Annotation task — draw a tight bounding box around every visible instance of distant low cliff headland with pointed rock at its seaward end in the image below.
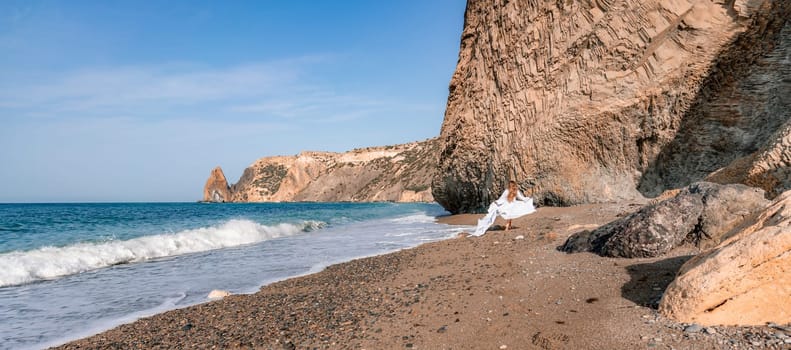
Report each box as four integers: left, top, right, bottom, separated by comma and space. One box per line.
203, 139, 437, 202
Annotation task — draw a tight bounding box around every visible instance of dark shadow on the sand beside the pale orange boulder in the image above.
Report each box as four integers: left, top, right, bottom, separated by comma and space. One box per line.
621, 255, 694, 309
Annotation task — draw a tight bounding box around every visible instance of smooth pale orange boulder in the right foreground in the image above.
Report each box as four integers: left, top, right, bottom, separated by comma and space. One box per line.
659, 191, 791, 325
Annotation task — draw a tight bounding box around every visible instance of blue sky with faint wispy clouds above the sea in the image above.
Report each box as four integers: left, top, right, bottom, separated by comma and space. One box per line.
0, 0, 466, 202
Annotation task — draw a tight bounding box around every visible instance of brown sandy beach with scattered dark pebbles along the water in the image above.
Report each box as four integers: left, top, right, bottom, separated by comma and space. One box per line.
59, 203, 791, 349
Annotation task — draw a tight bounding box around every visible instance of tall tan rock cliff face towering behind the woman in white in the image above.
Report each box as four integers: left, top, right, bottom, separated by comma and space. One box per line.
432, 0, 791, 213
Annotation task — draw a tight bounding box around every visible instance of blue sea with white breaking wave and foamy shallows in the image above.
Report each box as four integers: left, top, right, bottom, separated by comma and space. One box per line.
0, 203, 469, 349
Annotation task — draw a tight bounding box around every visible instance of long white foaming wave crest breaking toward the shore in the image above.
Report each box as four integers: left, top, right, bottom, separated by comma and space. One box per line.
0, 219, 326, 287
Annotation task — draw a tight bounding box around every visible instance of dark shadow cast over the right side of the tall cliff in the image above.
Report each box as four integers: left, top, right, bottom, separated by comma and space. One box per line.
637, 1, 791, 197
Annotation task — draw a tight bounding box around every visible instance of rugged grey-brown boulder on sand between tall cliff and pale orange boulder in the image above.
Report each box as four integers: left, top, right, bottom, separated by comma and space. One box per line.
561, 182, 768, 258
